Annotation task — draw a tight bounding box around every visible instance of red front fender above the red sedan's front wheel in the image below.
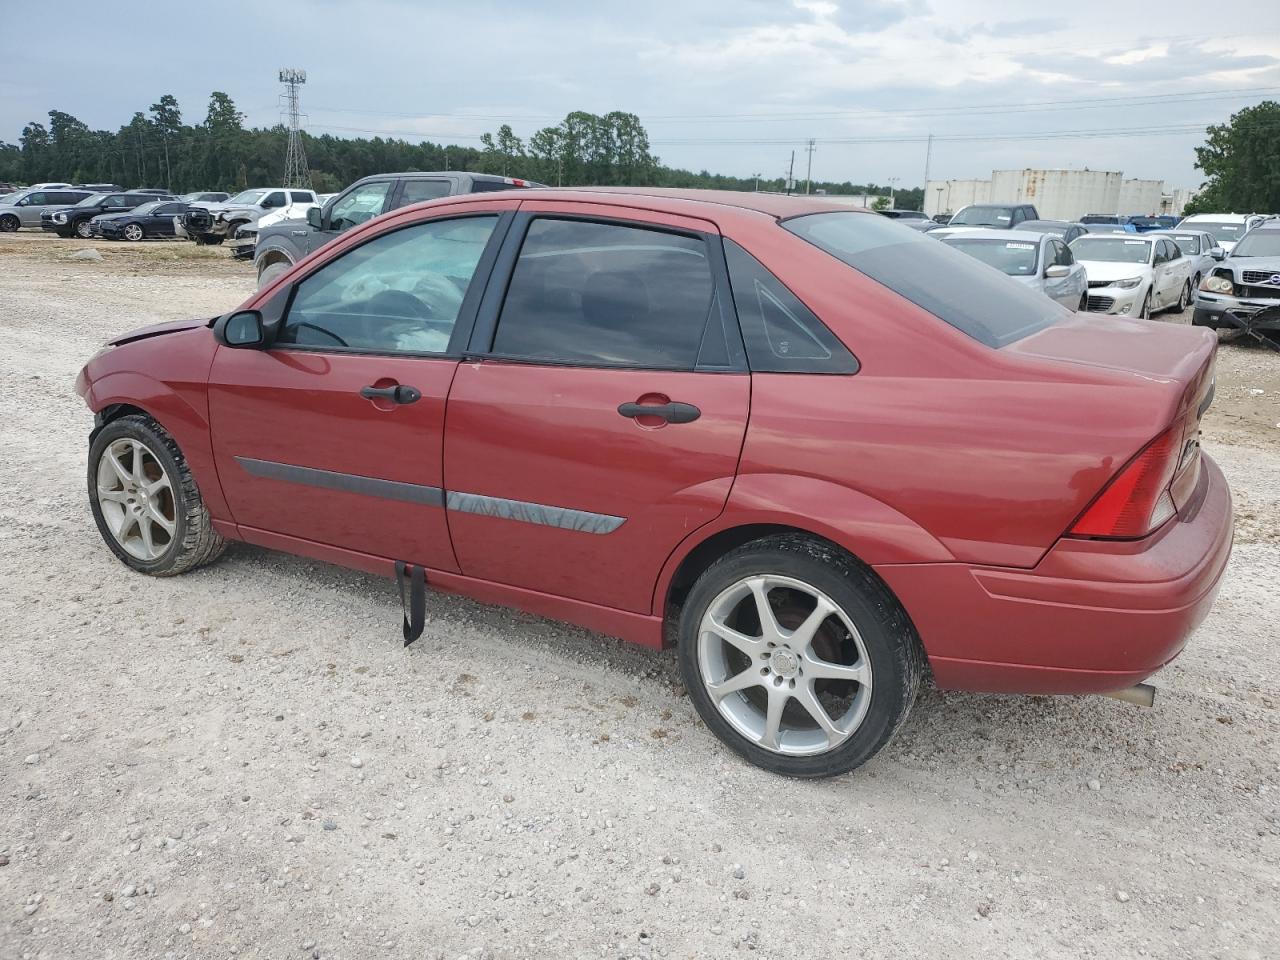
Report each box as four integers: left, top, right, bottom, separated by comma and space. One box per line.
76, 362, 230, 521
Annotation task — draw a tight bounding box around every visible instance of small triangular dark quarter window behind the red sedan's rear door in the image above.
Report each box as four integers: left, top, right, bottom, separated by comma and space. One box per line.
724, 239, 858, 374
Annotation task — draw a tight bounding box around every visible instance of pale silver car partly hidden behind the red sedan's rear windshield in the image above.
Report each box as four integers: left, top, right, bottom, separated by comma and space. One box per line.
933, 229, 1088, 310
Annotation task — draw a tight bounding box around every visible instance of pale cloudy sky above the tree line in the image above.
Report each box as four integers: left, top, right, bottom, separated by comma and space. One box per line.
0, 0, 1280, 187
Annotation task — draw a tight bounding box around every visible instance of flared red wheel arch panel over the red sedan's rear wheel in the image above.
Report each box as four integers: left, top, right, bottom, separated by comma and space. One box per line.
653, 474, 955, 616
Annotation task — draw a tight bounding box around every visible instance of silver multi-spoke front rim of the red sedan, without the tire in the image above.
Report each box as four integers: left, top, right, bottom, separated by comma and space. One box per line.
97, 438, 178, 561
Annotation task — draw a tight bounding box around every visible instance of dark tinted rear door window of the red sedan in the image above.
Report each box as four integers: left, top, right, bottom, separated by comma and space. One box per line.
493, 218, 713, 370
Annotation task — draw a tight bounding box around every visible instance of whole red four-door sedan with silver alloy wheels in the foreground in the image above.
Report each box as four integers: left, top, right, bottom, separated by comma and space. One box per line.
77, 189, 1231, 777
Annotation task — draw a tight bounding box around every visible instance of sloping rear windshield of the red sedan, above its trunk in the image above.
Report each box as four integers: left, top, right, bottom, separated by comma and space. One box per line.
782, 212, 1071, 347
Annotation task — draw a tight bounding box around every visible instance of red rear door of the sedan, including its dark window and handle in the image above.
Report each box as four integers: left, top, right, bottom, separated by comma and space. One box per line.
444, 201, 750, 613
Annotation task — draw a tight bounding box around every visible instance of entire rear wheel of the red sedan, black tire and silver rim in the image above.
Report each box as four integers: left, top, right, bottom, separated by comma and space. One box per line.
678, 534, 924, 778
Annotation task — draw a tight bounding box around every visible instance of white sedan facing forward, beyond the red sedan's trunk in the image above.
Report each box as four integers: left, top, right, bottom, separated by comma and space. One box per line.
1071, 233, 1192, 319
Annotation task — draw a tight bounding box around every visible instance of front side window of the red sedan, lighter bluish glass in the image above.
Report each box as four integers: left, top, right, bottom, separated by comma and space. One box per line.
278, 216, 498, 353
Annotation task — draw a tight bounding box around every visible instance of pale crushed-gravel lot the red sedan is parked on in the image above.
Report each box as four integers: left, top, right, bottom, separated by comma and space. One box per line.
0, 233, 1280, 960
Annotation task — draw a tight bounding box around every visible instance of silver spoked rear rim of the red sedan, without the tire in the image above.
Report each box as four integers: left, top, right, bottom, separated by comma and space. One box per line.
698, 575, 872, 756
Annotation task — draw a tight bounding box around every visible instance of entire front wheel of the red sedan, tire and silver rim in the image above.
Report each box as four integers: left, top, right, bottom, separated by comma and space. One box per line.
88, 415, 227, 576
